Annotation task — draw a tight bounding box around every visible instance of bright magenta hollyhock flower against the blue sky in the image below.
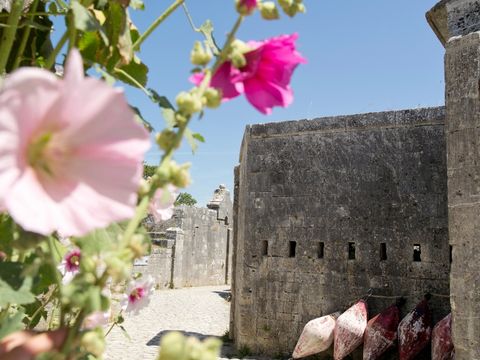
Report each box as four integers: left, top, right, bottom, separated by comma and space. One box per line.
191, 34, 306, 114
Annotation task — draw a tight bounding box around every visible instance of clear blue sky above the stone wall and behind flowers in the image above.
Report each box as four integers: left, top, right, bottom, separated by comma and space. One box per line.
79, 0, 444, 206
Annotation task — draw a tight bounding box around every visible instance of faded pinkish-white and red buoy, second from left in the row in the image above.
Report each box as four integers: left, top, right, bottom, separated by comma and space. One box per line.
334, 300, 368, 360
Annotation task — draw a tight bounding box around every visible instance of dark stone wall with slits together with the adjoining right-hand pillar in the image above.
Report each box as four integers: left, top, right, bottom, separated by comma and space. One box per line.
231, 0, 480, 360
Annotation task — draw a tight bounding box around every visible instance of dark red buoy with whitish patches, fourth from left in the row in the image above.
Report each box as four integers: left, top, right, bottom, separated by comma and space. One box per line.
398, 300, 432, 360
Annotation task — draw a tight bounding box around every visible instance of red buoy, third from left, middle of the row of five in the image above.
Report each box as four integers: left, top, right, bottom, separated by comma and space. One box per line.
363, 305, 400, 360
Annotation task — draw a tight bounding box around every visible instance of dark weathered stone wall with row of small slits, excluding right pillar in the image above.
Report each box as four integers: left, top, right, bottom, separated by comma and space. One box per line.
231, 107, 450, 354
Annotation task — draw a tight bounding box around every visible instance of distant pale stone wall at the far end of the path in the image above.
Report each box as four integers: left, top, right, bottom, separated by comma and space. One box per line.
134, 185, 232, 288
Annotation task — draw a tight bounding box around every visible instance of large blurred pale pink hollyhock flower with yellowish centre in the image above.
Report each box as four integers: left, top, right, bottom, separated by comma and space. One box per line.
0, 50, 149, 236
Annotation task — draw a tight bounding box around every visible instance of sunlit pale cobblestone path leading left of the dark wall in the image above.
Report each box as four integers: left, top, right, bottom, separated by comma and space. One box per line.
105, 286, 231, 360
